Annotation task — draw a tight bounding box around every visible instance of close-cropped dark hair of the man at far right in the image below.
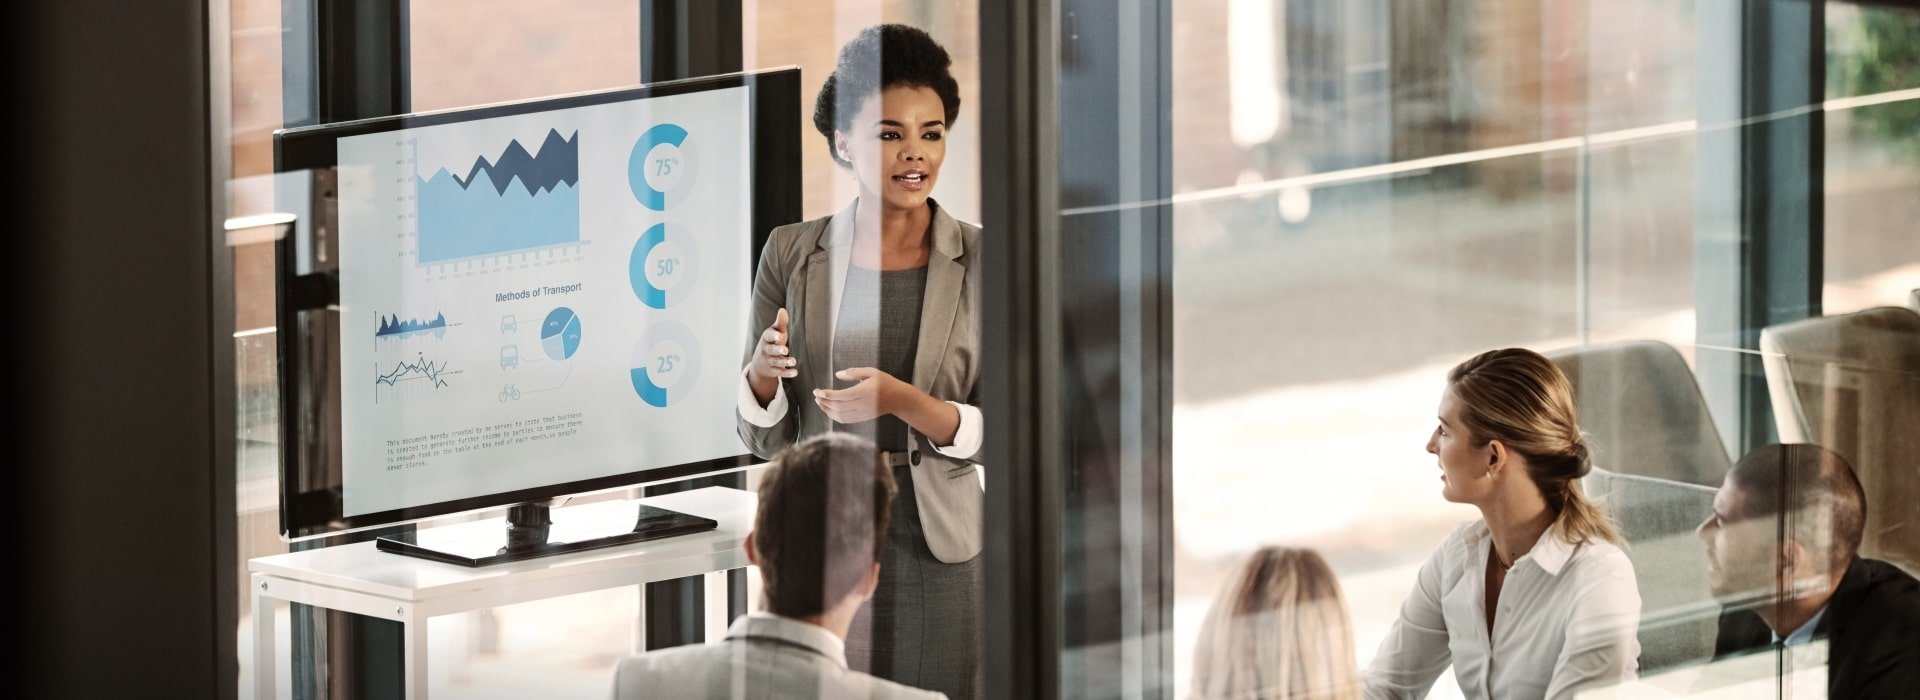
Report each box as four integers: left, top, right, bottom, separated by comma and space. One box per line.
1726, 443, 1866, 572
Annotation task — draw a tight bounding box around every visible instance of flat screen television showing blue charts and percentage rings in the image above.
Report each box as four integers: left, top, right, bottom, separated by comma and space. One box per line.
275, 69, 801, 564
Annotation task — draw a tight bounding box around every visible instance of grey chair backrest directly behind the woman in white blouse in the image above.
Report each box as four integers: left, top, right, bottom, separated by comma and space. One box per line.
1546, 339, 1734, 487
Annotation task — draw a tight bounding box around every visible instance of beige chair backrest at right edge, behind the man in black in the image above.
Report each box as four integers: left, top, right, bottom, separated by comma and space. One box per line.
1761, 307, 1920, 572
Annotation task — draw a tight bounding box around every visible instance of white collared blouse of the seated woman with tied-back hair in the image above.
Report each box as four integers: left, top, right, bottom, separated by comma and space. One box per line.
1367, 520, 1640, 700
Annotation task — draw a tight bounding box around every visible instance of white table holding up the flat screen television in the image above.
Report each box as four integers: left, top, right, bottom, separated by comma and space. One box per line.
248, 487, 756, 698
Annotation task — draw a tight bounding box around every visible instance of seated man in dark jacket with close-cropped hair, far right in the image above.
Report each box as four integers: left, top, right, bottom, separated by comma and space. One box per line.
1699, 445, 1920, 698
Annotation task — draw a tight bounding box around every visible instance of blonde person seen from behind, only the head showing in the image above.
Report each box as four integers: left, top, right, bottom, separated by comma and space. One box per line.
1190, 547, 1359, 700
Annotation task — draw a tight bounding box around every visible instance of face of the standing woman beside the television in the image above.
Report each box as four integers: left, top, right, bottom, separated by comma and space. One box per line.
833, 86, 947, 211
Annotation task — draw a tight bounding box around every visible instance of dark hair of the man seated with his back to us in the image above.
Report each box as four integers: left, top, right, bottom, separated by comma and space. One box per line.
753, 433, 899, 618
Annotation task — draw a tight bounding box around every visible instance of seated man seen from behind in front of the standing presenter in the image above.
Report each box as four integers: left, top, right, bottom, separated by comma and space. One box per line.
614, 433, 945, 700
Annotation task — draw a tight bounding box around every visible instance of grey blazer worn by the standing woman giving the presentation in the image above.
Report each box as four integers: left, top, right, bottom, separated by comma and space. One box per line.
737, 201, 981, 564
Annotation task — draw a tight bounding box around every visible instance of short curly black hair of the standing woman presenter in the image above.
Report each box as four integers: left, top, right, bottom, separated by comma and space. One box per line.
814, 25, 960, 165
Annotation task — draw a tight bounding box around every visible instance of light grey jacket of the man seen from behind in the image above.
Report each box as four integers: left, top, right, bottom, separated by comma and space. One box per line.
612, 612, 947, 700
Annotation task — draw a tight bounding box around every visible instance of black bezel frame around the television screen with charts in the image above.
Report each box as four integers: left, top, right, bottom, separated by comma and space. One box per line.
273, 67, 803, 539
